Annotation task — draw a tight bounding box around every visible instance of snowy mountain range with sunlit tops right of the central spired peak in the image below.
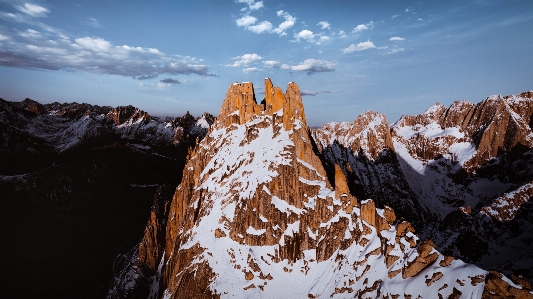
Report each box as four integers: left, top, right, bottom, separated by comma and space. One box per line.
313, 92, 533, 286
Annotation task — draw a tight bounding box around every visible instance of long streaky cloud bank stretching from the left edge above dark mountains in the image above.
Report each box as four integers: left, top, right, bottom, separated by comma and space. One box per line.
0, 29, 211, 79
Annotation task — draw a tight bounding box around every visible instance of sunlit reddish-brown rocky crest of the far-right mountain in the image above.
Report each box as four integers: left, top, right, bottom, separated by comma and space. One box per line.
392, 91, 533, 171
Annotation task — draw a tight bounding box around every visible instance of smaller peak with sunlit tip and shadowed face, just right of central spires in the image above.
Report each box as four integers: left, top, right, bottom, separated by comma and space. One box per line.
312, 111, 429, 229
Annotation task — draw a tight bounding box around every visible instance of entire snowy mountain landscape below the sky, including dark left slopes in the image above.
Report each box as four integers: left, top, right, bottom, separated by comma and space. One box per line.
0, 79, 533, 298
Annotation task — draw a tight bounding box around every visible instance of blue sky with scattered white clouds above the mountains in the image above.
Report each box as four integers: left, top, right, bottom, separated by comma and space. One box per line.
0, 0, 533, 126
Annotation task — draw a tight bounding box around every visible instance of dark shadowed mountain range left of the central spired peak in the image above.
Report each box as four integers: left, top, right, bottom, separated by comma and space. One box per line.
0, 99, 213, 298
